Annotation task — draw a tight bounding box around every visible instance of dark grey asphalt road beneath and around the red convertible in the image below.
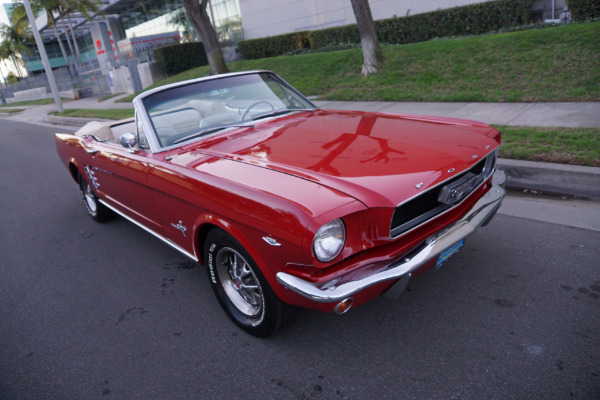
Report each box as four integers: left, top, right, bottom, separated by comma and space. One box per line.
0, 119, 600, 400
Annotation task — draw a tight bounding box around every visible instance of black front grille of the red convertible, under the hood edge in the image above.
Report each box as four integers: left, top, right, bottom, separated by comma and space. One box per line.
390, 152, 496, 238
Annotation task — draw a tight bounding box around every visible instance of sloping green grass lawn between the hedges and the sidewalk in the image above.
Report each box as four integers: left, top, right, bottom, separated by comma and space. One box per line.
118, 22, 600, 102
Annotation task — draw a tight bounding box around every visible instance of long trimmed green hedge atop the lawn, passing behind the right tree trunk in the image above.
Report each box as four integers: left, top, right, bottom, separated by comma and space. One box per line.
238, 0, 536, 59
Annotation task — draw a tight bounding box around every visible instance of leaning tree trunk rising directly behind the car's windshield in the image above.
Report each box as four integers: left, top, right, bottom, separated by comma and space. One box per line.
183, 0, 229, 74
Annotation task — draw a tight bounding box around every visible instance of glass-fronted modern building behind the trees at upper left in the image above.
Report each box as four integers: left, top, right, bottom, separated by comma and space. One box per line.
24, 0, 243, 74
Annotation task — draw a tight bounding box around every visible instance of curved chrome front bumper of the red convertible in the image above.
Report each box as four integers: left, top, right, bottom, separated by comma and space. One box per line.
277, 170, 506, 303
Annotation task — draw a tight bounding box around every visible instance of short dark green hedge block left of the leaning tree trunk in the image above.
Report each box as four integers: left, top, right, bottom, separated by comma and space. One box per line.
152, 42, 208, 76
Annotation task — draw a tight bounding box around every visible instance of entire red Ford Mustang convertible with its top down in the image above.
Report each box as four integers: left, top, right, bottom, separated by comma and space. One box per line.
56, 71, 505, 337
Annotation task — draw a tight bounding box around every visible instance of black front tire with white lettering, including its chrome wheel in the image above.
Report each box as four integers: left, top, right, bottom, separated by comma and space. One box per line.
204, 228, 294, 337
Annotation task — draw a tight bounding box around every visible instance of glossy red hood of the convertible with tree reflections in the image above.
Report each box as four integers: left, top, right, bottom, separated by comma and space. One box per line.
182, 110, 498, 207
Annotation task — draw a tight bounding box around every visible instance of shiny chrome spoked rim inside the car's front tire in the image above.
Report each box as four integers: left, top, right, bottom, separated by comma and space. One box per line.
215, 247, 264, 318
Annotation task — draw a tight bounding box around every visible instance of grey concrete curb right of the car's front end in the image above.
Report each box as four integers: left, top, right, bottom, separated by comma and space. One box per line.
496, 159, 600, 200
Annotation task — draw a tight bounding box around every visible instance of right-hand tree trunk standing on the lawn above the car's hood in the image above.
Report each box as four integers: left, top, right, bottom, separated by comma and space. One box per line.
350, 0, 383, 76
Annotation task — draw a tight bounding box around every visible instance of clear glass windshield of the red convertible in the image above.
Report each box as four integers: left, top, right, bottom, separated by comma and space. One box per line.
142, 73, 316, 148
